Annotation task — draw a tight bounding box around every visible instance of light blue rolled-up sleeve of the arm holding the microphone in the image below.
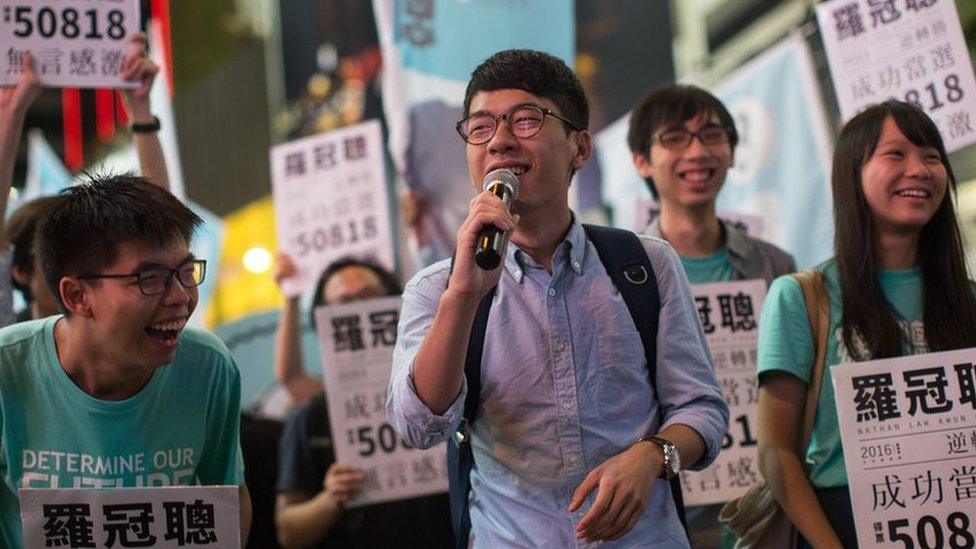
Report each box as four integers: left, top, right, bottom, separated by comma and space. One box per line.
386, 260, 467, 448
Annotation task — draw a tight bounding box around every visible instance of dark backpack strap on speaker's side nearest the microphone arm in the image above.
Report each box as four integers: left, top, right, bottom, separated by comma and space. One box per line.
447, 282, 495, 549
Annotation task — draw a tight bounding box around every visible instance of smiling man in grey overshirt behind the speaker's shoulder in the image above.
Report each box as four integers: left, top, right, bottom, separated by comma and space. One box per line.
627, 85, 796, 547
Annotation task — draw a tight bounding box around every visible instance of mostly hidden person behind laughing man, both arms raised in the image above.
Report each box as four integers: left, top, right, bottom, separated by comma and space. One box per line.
0, 33, 169, 326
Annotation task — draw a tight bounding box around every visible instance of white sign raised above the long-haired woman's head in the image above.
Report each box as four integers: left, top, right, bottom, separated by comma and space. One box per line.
817, 0, 976, 152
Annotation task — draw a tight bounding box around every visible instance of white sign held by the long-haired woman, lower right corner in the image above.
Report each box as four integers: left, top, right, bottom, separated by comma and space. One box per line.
830, 349, 976, 548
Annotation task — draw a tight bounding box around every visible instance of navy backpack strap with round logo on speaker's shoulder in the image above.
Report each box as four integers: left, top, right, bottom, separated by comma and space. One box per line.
583, 224, 688, 534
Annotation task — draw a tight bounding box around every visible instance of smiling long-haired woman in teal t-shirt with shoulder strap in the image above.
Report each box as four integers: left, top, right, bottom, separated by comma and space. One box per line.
758, 100, 976, 547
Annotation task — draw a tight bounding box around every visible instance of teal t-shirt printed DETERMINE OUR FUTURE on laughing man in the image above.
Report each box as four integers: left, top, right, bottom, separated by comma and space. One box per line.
0, 316, 244, 547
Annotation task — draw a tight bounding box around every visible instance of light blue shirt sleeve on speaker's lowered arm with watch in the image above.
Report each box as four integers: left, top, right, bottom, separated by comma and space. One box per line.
641, 236, 729, 470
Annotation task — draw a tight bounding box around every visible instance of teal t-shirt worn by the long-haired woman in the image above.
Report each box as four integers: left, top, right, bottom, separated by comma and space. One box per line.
758, 260, 927, 488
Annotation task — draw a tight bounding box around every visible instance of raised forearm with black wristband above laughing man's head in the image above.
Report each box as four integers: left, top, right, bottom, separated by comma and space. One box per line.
122, 33, 170, 190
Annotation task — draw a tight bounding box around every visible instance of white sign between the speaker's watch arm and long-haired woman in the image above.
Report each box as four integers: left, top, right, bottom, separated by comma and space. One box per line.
681, 280, 766, 506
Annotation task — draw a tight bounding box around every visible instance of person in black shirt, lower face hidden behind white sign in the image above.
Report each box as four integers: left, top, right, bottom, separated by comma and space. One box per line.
275, 254, 452, 547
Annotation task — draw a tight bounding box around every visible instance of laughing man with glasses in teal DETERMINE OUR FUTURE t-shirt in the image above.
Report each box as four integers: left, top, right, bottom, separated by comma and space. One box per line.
0, 175, 250, 547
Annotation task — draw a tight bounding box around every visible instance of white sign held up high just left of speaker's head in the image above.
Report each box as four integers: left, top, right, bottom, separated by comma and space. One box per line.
271, 120, 393, 296
